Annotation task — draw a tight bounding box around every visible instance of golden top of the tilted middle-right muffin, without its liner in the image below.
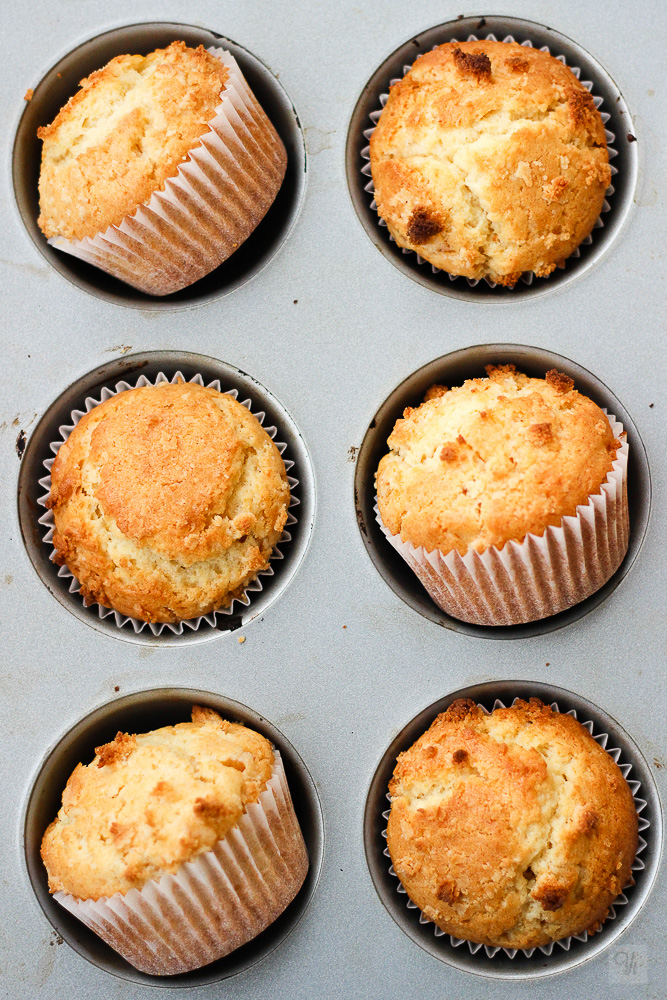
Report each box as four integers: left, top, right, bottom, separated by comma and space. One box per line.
376, 365, 619, 554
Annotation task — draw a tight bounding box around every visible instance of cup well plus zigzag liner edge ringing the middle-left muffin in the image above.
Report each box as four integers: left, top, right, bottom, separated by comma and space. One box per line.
18, 352, 314, 645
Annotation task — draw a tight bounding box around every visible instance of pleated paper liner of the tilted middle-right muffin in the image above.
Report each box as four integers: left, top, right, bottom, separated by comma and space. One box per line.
375, 409, 630, 625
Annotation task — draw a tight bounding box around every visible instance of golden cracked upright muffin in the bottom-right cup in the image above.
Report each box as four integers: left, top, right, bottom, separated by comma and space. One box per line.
387, 698, 638, 948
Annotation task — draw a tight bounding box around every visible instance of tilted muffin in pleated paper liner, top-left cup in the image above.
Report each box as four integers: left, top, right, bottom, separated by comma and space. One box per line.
37, 41, 287, 294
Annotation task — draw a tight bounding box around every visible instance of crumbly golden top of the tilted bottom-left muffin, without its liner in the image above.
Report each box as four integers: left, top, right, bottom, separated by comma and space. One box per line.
42, 706, 274, 900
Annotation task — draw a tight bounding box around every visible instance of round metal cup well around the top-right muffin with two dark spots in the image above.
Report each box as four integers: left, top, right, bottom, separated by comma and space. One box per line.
346, 16, 638, 302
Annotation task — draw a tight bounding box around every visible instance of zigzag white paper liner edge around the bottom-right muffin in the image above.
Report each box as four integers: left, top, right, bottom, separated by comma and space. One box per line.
381, 698, 651, 958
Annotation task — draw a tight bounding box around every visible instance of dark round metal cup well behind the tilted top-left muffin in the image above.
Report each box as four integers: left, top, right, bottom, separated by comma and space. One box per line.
12, 22, 306, 309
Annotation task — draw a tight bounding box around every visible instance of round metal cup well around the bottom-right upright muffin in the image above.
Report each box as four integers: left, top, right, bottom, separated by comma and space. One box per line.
364, 681, 662, 979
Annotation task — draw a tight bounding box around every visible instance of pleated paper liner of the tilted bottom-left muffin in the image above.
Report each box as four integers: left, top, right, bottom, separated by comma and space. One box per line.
54, 751, 308, 976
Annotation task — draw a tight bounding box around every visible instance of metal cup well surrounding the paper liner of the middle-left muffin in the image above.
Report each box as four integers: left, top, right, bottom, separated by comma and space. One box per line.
18, 351, 315, 646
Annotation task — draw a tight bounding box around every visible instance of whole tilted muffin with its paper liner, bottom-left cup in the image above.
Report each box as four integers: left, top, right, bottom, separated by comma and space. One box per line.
42, 706, 308, 975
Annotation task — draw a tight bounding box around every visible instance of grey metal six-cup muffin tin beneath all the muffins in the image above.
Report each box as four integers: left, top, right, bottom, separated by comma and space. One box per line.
6, 7, 667, 1000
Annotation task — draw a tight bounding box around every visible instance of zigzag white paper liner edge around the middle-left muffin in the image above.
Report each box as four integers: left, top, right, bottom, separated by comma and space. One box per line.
37, 371, 301, 635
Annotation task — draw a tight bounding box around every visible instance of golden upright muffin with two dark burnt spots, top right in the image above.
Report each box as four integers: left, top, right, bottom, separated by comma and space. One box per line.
370, 41, 611, 286
